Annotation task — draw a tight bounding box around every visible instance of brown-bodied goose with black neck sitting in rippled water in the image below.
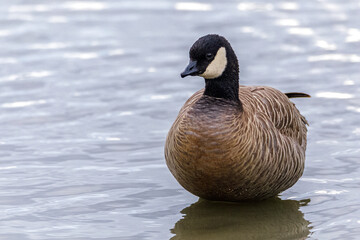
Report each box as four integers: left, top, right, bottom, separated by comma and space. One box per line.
165, 34, 310, 202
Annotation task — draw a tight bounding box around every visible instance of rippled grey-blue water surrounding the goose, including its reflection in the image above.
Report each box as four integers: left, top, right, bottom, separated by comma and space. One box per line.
0, 0, 360, 240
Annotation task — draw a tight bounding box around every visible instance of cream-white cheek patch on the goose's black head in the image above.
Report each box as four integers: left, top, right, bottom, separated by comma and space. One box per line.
199, 47, 227, 79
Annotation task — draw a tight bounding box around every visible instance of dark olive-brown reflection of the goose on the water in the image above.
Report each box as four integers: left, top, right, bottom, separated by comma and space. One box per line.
171, 198, 310, 240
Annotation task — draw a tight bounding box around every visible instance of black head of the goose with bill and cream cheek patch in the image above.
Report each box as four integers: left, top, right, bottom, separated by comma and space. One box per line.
181, 34, 239, 79
